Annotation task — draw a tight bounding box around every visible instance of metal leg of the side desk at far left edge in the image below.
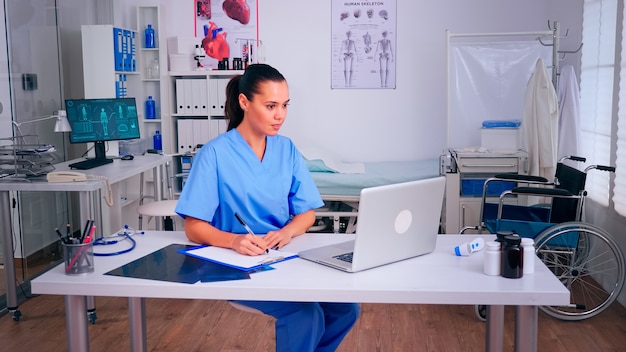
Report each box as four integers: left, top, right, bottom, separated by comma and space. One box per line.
0, 191, 21, 321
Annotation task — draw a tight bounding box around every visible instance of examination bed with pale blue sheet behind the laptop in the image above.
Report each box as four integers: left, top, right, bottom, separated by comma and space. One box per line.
307, 157, 439, 233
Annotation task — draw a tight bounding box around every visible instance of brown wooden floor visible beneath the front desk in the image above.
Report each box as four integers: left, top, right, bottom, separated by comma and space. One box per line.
0, 296, 626, 352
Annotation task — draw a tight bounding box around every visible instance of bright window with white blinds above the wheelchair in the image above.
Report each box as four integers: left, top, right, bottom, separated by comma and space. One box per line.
580, 0, 626, 209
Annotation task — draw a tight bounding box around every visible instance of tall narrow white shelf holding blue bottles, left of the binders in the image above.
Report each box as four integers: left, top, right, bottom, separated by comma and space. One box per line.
137, 5, 167, 152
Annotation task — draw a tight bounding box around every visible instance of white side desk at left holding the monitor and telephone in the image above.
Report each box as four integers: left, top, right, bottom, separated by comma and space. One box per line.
0, 154, 171, 320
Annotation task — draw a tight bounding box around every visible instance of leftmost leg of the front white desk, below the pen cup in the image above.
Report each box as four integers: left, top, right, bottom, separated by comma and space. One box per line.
65, 296, 89, 352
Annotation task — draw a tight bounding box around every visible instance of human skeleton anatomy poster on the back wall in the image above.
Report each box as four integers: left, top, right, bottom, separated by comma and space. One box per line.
331, 0, 397, 89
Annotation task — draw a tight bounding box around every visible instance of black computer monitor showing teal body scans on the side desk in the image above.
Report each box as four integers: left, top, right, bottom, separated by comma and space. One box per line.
65, 98, 140, 167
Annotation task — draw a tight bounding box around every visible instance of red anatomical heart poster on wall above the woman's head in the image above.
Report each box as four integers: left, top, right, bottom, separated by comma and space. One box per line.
194, 0, 258, 69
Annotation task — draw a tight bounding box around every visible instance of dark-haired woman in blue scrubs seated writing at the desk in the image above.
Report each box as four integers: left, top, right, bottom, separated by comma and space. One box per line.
176, 64, 360, 352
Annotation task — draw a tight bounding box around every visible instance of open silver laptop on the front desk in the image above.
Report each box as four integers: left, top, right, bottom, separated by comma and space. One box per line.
298, 177, 446, 272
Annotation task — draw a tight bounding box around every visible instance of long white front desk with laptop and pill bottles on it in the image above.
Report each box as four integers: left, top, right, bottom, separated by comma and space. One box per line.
31, 231, 570, 351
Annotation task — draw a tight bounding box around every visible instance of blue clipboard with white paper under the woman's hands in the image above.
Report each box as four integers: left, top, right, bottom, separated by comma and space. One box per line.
179, 245, 298, 272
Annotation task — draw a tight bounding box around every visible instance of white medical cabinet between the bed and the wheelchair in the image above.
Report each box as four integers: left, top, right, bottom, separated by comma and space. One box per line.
441, 150, 528, 233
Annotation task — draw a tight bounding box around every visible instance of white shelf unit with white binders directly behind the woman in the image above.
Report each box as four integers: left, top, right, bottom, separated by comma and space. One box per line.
163, 70, 243, 193
